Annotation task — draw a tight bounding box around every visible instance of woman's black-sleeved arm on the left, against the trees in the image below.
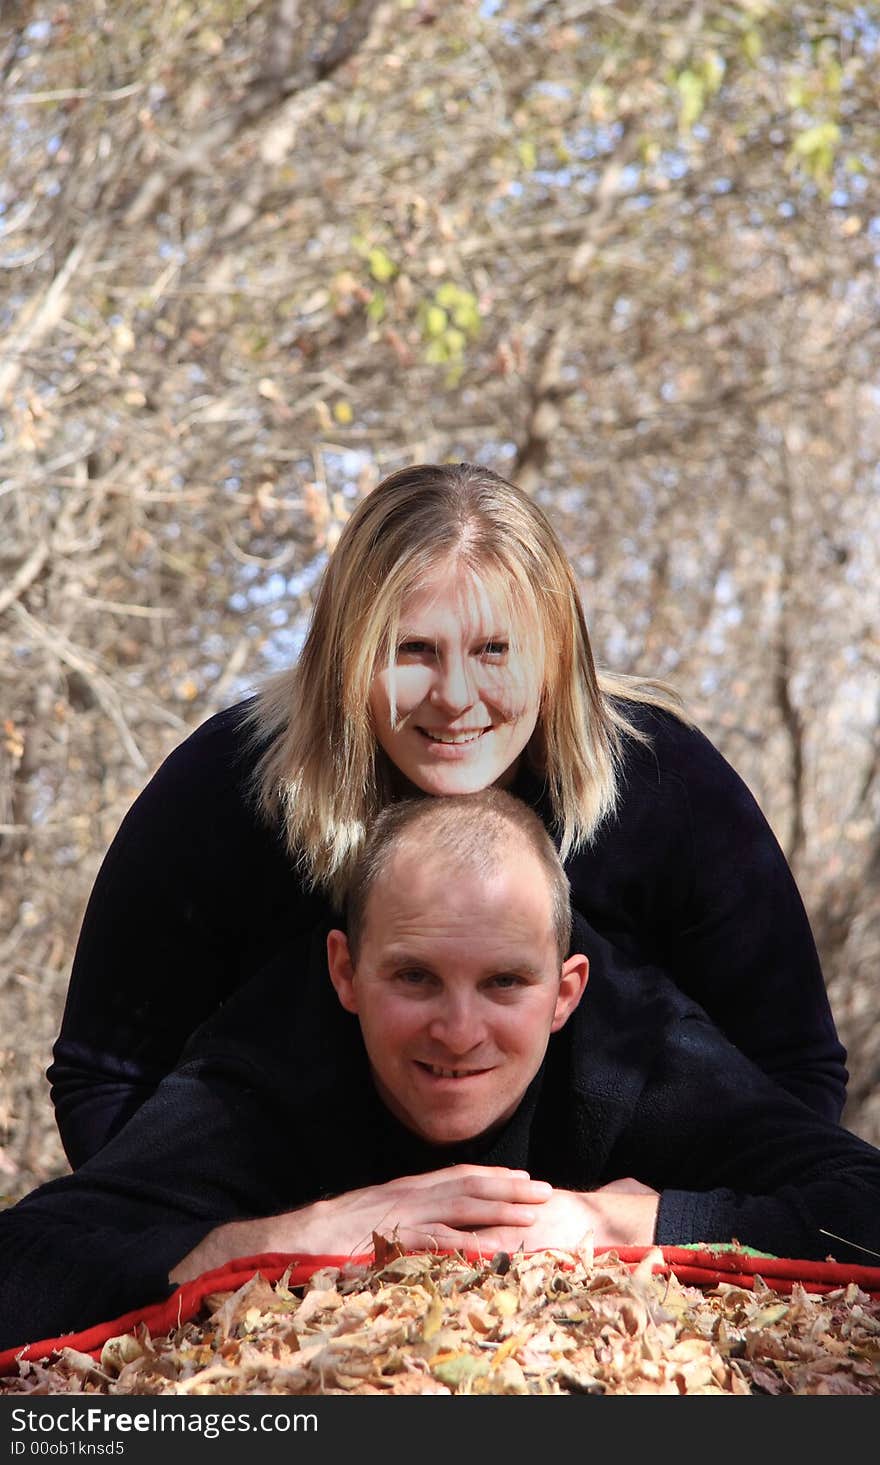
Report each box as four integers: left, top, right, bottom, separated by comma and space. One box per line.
48, 708, 319, 1166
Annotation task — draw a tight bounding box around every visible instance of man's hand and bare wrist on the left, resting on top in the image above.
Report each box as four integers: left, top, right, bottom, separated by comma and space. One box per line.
170, 1165, 550, 1283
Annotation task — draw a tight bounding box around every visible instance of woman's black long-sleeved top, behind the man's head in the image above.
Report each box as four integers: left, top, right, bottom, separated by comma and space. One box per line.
48, 703, 846, 1166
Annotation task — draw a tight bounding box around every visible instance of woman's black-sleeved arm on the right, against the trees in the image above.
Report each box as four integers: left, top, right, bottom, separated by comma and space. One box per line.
568, 708, 848, 1121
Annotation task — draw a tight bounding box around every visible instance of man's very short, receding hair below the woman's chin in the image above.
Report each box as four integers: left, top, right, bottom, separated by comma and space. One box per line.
346, 788, 571, 963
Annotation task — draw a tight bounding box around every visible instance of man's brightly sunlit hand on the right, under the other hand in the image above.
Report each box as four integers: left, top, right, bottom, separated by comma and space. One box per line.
495, 1179, 660, 1251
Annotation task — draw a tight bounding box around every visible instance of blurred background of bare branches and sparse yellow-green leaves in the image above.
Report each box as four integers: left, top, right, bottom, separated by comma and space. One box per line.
0, 0, 880, 1198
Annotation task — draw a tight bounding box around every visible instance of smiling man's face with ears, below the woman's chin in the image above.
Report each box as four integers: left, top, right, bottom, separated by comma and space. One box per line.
328, 826, 587, 1144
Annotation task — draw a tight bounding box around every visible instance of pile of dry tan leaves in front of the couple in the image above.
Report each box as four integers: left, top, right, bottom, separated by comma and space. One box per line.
0, 1247, 880, 1395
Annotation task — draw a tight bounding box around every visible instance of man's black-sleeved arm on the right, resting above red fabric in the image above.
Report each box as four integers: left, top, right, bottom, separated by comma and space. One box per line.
606, 1014, 880, 1264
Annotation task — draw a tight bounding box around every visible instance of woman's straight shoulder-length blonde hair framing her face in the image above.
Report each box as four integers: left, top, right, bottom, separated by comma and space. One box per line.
250, 463, 682, 904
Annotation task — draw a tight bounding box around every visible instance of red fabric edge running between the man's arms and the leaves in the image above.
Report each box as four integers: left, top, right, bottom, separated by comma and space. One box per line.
0, 1247, 880, 1374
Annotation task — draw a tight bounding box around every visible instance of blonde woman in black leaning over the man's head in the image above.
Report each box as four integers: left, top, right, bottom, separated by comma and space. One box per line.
48, 463, 846, 1166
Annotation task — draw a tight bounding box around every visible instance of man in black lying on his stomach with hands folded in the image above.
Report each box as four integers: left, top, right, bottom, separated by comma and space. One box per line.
0, 790, 880, 1346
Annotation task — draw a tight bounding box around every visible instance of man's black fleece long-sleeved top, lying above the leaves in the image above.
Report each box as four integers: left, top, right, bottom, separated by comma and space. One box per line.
0, 921, 880, 1348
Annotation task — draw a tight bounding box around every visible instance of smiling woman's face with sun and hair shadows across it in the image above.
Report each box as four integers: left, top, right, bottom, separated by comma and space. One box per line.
370, 561, 543, 795
